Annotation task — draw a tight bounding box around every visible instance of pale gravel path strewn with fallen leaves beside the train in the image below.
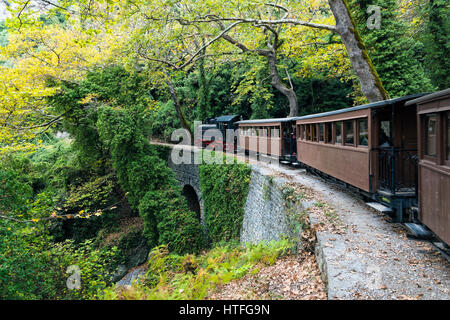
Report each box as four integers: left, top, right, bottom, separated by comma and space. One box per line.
268, 167, 450, 300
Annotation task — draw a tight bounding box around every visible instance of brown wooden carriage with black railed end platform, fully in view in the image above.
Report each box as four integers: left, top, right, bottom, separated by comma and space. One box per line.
296, 94, 423, 222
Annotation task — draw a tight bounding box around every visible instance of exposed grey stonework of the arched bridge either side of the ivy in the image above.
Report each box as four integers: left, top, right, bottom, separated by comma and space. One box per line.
163, 145, 291, 243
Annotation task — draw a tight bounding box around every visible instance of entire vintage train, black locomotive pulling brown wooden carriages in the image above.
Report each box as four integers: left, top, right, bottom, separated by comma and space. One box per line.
195, 89, 450, 249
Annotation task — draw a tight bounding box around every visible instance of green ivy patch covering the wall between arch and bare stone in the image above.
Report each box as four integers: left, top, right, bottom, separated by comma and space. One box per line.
199, 161, 251, 243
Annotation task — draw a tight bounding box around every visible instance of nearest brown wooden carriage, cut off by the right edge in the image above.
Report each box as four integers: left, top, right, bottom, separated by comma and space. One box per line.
406, 89, 450, 243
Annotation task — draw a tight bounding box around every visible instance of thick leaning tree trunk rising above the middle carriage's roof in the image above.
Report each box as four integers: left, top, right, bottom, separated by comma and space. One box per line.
328, 0, 389, 102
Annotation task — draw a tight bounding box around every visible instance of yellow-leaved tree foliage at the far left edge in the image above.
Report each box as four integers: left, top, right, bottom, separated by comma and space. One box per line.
0, 3, 118, 150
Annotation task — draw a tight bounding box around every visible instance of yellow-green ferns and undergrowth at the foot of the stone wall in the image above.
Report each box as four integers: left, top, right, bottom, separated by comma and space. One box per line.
100, 240, 292, 300
